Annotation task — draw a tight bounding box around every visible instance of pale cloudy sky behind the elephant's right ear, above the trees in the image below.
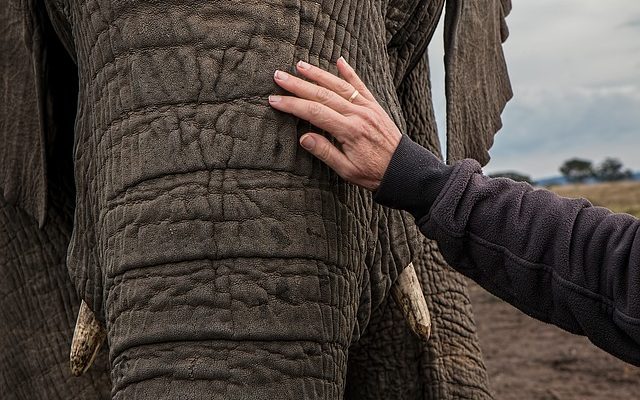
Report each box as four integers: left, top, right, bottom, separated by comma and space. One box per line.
429, 0, 640, 179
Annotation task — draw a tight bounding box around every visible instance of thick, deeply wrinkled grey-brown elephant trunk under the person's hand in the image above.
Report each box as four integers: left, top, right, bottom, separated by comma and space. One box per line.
62, 0, 420, 399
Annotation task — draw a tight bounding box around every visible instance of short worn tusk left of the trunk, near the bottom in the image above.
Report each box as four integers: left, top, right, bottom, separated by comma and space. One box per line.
69, 300, 107, 376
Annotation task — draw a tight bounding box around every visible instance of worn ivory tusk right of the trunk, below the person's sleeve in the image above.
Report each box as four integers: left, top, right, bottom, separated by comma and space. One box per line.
391, 263, 431, 340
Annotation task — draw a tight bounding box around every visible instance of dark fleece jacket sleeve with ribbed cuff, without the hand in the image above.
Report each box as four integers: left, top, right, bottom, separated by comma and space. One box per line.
374, 137, 640, 366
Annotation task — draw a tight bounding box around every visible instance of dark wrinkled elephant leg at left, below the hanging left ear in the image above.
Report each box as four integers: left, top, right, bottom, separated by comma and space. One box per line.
0, 191, 111, 400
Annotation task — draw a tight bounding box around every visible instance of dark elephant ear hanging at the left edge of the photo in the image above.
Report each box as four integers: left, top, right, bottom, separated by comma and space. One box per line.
0, 1, 47, 225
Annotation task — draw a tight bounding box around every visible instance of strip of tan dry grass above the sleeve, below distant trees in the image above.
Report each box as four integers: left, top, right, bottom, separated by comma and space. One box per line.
549, 181, 640, 218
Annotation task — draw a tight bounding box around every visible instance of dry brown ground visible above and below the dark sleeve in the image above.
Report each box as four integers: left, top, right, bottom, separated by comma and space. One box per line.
470, 182, 640, 400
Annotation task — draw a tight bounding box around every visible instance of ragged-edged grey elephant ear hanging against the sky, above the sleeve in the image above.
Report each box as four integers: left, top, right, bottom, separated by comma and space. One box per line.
444, 0, 513, 165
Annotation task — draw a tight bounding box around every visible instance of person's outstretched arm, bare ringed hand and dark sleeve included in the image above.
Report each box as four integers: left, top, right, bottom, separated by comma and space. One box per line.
272, 58, 640, 365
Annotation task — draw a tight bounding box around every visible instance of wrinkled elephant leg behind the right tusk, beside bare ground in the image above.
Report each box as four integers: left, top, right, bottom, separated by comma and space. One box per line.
345, 239, 492, 400
